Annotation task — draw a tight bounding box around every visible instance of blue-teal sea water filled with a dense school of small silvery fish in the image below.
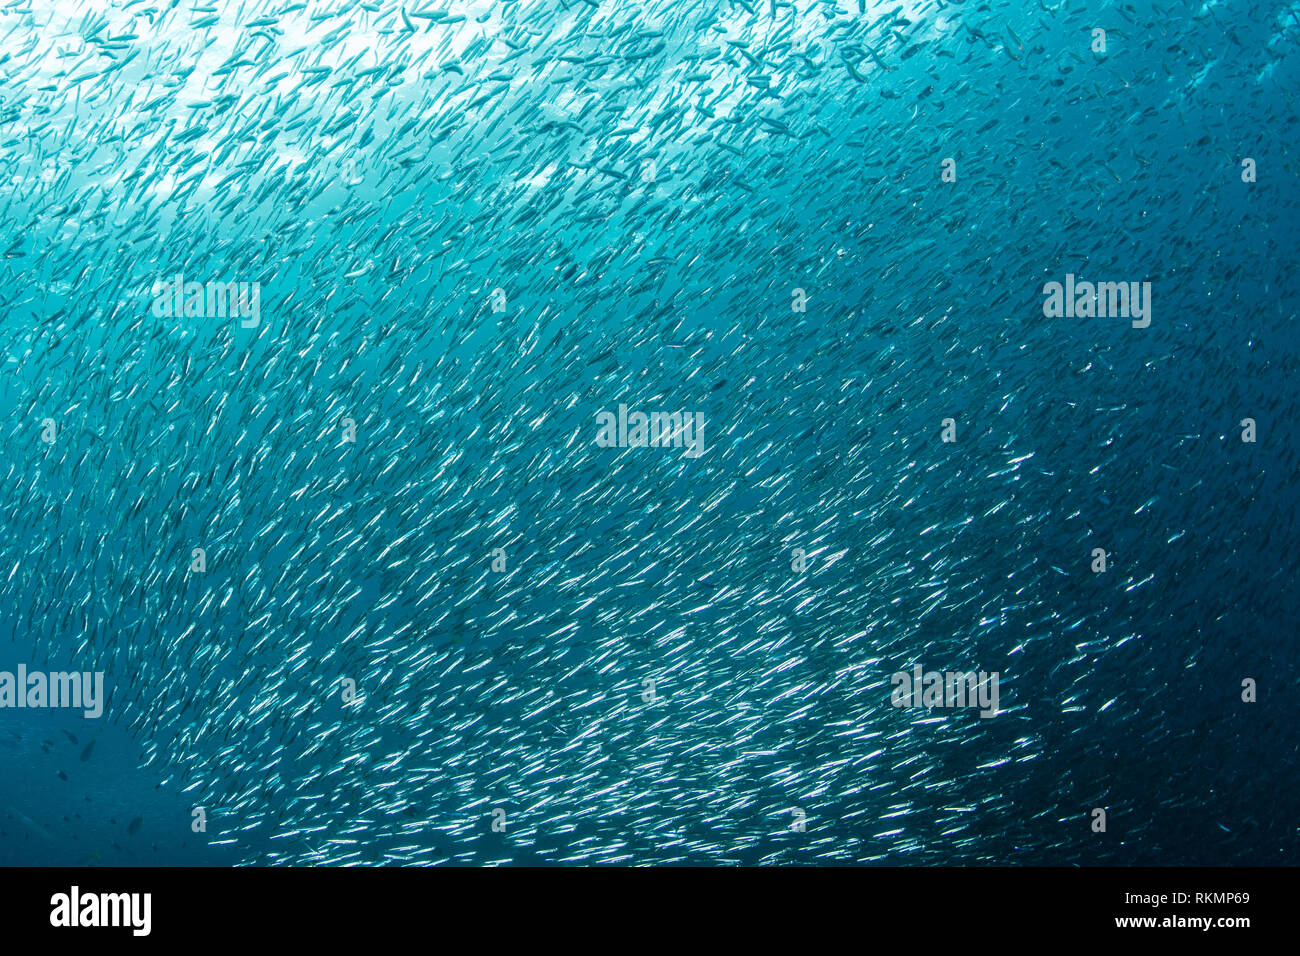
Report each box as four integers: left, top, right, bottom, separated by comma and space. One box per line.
0, 0, 1300, 866
